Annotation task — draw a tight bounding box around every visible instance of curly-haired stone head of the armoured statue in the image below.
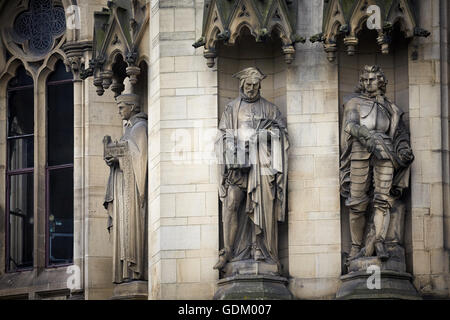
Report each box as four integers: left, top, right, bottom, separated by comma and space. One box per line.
357, 65, 388, 97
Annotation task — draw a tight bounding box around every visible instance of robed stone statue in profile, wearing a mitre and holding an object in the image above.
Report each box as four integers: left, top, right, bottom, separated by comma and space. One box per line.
103, 94, 148, 283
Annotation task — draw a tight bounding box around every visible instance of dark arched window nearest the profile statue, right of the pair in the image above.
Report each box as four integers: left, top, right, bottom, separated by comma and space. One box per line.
46, 61, 74, 266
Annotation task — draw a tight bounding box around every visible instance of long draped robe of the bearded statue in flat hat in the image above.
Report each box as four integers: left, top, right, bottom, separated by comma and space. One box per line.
216, 97, 289, 264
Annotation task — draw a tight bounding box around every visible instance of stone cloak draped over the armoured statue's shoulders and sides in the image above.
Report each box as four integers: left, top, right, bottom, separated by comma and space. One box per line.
340, 95, 411, 203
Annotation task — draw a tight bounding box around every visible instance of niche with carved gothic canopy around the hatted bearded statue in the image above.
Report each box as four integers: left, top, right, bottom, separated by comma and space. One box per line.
205, 0, 304, 276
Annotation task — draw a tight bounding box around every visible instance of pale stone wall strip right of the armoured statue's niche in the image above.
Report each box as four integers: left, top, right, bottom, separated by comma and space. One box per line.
409, 0, 449, 296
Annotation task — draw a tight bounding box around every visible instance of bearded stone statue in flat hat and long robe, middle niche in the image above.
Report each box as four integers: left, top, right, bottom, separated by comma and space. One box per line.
214, 67, 289, 274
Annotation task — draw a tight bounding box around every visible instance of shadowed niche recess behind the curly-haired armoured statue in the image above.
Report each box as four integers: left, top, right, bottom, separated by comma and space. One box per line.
336, 23, 412, 272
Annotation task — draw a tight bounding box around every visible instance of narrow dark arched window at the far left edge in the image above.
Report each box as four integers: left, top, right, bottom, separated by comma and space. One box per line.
6, 66, 34, 271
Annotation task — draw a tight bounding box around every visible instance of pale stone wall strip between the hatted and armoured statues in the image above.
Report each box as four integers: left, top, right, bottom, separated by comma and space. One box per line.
287, 0, 341, 299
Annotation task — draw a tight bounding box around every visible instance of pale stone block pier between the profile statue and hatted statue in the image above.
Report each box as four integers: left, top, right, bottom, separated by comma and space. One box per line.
149, 0, 218, 299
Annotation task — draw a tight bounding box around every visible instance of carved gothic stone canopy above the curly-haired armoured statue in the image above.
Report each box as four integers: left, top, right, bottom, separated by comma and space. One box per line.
310, 0, 430, 62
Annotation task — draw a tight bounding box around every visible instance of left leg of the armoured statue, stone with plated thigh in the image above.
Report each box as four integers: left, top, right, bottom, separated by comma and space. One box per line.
348, 160, 370, 258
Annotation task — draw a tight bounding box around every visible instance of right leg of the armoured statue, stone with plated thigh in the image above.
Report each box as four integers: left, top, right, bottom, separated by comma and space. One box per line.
373, 160, 394, 260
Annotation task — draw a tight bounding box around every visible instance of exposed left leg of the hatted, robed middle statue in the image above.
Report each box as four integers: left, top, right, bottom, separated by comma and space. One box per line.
214, 185, 245, 269
